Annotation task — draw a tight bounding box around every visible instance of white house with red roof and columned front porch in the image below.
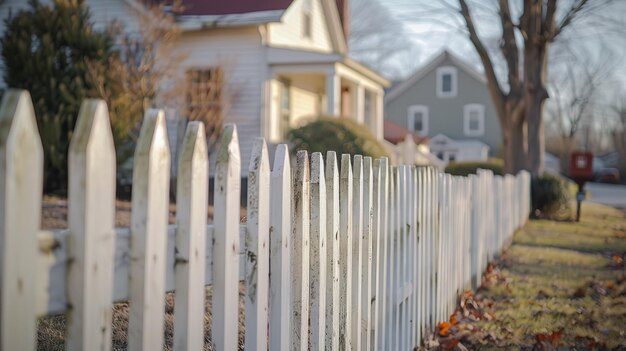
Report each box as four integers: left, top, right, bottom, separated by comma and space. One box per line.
0, 0, 389, 169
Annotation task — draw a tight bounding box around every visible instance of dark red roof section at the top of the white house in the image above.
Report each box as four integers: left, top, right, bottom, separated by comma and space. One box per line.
171, 0, 293, 16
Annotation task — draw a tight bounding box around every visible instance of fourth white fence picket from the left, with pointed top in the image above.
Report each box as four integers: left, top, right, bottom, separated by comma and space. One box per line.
173, 121, 209, 351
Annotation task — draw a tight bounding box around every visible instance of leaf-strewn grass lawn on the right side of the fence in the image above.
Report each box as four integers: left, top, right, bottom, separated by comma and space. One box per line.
454, 203, 626, 350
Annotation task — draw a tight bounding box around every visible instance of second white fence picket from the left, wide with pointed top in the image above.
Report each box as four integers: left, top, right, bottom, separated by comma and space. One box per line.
67, 99, 116, 350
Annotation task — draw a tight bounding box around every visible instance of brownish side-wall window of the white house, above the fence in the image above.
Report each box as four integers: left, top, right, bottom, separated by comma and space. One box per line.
184, 67, 224, 134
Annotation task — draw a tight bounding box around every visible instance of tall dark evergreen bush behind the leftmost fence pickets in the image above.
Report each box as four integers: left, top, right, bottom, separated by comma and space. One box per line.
0, 0, 141, 193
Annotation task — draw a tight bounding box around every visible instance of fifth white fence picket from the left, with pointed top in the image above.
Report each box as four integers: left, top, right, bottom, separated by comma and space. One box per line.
212, 124, 241, 351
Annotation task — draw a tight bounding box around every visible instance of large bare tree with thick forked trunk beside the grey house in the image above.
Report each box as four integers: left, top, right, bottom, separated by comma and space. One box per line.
448, 0, 613, 176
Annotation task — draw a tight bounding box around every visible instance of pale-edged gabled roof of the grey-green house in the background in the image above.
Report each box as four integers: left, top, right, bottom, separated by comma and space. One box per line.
385, 50, 487, 102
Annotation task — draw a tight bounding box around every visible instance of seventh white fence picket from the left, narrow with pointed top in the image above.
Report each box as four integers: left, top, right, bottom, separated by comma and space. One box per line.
269, 144, 292, 351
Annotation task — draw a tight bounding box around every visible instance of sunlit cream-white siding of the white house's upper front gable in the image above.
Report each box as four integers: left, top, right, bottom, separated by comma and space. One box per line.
268, 0, 333, 52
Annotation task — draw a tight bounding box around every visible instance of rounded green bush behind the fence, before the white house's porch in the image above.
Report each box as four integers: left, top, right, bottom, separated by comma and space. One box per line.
287, 116, 388, 158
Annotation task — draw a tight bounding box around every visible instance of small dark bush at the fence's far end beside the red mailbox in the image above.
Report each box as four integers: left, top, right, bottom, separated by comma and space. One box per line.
531, 173, 571, 218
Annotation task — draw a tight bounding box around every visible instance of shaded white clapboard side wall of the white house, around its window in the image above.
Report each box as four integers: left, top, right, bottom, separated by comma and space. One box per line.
175, 28, 267, 173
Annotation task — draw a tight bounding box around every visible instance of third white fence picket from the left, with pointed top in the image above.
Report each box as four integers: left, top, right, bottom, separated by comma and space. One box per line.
128, 109, 170, 351
